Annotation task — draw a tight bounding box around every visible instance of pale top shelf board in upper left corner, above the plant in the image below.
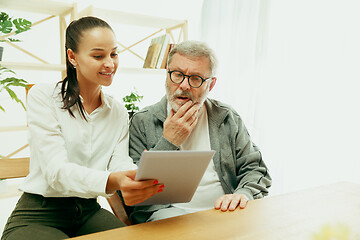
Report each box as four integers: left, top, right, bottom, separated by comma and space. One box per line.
0, 0, 73, 15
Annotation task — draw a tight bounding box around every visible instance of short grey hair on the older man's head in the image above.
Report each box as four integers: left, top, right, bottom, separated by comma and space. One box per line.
167, 40, 217, 77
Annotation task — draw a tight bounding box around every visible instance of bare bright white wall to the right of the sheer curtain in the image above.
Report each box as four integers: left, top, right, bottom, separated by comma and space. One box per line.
258, 0, 360, 192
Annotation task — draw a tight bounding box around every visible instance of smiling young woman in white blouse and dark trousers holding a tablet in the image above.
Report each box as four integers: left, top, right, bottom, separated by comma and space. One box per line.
1, 17, 163, 240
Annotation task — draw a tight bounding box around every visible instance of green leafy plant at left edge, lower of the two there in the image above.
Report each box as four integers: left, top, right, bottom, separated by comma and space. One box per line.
0, 65, 29, 112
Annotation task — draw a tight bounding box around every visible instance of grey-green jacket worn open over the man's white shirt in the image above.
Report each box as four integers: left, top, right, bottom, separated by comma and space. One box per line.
129, 97, 271, 223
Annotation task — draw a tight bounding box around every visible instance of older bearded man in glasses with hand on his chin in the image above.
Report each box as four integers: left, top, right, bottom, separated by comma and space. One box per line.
129, 41, 271, 223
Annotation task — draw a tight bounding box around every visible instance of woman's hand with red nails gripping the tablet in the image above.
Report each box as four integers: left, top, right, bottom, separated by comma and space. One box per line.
106, 170, 164, 206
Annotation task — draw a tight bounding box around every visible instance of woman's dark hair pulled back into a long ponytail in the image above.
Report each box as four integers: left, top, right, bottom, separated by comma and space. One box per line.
58, 17, 112, 120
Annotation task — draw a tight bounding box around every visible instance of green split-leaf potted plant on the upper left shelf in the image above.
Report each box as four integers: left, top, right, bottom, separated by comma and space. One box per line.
0, 12, 32, 61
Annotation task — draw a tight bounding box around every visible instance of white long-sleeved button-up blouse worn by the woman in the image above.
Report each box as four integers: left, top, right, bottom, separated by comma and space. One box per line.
20, 84, 136, 198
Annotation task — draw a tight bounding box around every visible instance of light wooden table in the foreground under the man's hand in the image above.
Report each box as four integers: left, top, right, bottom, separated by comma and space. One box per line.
69, 182, 360, 240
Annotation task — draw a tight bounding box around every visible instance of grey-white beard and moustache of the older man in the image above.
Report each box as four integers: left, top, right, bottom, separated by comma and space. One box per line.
165, 83, 210, 112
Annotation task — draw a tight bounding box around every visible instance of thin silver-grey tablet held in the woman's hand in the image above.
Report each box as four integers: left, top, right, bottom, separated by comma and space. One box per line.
135, 150, 215, 206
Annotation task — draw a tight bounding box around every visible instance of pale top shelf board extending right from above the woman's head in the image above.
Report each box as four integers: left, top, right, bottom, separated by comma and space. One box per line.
79, 6, 186, 29
